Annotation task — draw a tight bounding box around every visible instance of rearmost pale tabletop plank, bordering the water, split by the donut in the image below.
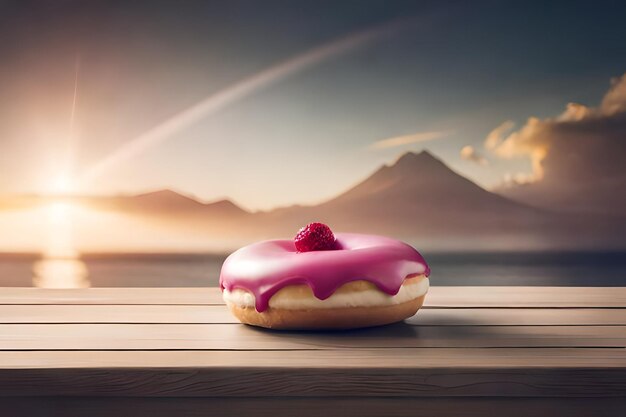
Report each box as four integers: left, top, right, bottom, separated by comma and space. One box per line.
0, 288, 626, 308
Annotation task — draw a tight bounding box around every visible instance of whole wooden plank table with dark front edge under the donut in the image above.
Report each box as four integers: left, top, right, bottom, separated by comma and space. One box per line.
0, 287, 626, 417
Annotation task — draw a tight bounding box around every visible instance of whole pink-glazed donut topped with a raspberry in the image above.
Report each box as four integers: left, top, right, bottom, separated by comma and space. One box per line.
220, 223, 430, 330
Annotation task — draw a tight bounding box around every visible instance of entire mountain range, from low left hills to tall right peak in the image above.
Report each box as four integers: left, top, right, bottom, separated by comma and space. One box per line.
1, 151, 626, 250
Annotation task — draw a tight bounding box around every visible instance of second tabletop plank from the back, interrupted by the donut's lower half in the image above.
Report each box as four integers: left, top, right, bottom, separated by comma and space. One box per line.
0, 304, 626, 326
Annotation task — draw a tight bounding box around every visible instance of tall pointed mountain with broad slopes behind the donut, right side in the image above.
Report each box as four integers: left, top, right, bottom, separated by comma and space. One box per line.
254, 151, 626, 249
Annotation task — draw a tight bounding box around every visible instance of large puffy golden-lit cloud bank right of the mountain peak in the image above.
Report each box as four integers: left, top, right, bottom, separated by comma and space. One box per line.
485, 74, 626, 187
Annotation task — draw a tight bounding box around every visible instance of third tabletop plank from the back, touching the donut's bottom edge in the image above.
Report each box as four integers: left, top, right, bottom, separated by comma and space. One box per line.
0, 323, 626, 350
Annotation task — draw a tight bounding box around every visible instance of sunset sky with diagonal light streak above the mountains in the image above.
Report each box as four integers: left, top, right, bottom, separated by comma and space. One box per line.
0, 0, 626, 210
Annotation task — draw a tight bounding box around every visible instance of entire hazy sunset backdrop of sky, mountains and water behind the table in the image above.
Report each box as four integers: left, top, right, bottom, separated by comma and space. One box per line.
0, 0, 626, 287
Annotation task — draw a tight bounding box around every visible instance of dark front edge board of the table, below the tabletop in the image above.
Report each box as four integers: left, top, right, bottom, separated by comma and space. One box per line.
0, 367, 626, 397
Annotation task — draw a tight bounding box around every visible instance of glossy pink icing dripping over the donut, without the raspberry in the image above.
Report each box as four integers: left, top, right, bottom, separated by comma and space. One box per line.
220, 233, 430, 312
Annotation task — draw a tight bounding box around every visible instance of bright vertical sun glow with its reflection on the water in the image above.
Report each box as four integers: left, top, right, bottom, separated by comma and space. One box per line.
33, 201, 89, 288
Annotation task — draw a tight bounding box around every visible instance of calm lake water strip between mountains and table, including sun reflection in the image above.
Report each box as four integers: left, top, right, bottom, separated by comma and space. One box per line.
0, 252, 626, 288
